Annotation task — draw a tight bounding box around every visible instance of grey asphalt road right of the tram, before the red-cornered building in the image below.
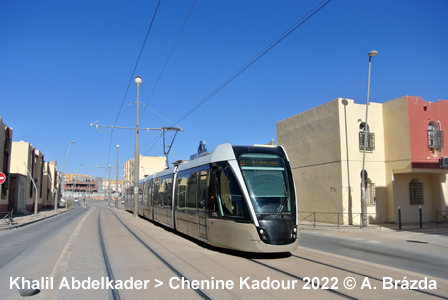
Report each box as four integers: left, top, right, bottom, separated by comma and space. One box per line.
299, 230, 448, 279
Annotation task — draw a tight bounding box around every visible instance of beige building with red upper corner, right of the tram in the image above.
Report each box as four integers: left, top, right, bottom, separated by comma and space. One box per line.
277, 96, 448, 224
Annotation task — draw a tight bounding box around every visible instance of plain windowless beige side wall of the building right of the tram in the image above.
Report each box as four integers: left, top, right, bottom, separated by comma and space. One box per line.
277, 99, 343, 217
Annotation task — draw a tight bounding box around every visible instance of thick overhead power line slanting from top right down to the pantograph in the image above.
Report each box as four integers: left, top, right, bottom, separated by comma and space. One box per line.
176, 0, 331, 125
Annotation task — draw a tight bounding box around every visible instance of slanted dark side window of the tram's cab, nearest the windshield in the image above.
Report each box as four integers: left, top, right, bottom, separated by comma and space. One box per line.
215, 167, 250, 219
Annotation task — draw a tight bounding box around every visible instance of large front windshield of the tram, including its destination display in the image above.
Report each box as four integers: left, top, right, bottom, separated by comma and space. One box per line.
238, 153, 293, 215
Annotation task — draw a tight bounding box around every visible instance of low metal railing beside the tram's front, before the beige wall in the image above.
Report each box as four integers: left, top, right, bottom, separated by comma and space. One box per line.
298, 211, 381, 229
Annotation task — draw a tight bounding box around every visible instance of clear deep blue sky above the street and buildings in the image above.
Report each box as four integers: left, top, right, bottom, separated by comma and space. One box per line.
0, 0, 448, 178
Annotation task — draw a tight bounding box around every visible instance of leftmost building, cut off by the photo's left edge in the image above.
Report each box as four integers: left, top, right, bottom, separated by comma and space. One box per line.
0, 117, 12, 216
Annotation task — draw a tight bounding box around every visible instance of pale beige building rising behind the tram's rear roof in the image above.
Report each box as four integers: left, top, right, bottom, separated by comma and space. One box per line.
123, 155, 166, 188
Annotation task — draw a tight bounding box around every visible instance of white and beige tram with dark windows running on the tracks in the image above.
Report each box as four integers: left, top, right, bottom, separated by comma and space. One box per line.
125, 144, 299, 252
